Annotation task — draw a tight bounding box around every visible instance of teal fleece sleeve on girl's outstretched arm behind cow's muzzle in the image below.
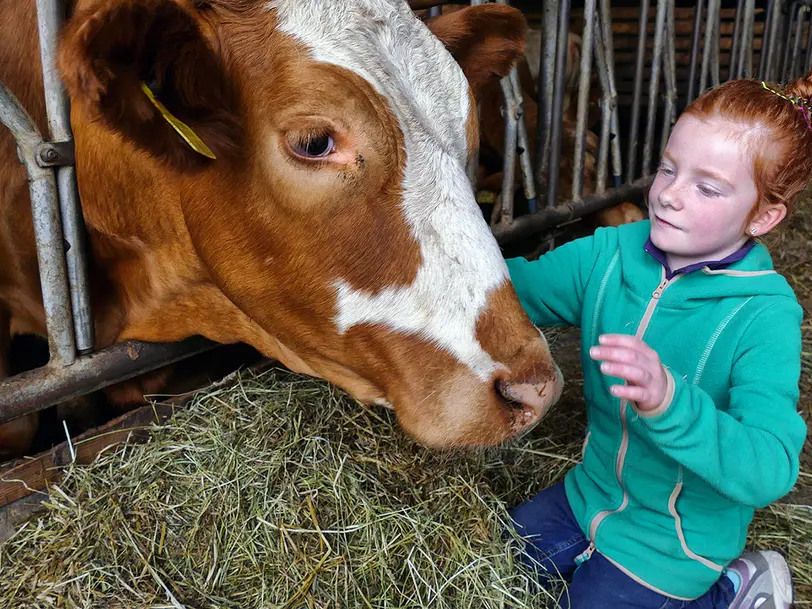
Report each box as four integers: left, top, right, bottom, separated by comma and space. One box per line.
506, 229, 606, 327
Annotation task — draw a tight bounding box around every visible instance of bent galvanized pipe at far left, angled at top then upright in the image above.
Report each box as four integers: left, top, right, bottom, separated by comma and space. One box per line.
0, 82, 76, 366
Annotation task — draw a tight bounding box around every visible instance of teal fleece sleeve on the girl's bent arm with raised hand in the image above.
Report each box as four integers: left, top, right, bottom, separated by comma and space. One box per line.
641, 299, 807, 508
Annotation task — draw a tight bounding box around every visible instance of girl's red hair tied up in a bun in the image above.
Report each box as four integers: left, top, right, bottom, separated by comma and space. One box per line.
683, 72, 812, 216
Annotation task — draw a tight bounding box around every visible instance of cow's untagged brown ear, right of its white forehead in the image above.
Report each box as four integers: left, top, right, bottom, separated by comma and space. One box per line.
426, 4, 527, 94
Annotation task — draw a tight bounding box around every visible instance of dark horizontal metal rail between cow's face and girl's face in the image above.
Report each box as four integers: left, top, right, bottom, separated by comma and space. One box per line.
492, 176, 654, 244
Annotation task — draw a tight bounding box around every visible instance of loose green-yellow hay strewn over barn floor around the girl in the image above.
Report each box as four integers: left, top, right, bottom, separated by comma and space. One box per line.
0, 205, 812, 609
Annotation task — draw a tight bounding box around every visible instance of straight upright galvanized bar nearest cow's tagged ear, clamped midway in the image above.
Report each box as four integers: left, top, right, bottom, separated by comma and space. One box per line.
37, 0, 95, 353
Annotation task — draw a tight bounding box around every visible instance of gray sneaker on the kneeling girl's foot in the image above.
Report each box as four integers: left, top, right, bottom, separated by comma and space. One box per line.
727, 550, 792, 609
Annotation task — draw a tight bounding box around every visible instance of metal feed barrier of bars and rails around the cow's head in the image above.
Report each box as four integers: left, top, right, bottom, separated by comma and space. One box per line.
0, 0, 812, 424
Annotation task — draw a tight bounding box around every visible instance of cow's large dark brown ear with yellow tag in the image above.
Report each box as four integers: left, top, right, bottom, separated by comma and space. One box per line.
59, 0, 243, 170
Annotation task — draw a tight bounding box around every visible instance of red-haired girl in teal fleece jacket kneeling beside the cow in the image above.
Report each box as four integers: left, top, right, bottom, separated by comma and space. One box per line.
508, 74, 812, 609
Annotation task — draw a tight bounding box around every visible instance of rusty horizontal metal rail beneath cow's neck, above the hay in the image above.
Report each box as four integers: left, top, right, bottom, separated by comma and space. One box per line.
0, 336, 217, 424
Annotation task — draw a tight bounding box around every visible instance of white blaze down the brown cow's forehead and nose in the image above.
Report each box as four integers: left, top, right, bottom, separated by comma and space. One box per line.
269, 0, 508, 381
